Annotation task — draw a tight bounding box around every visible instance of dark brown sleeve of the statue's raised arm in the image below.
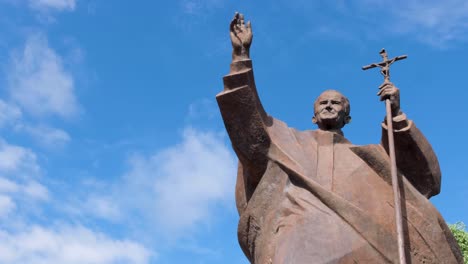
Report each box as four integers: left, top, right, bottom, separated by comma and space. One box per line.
216, 60, 271, 189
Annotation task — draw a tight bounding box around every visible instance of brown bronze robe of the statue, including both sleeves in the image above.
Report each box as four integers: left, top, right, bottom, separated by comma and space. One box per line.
217, 60, 463, 264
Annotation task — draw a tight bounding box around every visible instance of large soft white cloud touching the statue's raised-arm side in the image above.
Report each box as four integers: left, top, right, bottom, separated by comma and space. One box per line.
95, 128, 237, 235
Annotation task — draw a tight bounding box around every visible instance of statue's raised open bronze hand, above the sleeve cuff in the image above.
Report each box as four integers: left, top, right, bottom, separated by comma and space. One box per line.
229, 12, 253, 61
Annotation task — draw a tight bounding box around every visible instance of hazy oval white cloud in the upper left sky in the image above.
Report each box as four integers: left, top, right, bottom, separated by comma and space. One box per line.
8, 34, 79, 117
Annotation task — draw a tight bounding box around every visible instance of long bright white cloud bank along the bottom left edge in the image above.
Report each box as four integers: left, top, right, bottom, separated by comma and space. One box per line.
0, 225, 151, 264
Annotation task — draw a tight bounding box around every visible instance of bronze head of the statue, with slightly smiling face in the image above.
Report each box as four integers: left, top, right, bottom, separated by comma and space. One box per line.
312, 90, 351, 131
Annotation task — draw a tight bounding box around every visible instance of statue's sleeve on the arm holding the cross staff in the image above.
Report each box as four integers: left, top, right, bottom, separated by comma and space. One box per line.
381, 114, 441, 198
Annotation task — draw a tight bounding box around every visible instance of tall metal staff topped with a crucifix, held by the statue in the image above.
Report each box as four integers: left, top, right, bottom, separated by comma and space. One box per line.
362, 49, 407, 264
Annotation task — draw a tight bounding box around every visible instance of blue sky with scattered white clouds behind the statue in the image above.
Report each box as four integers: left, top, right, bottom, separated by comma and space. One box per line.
0, 0, 468, 264
